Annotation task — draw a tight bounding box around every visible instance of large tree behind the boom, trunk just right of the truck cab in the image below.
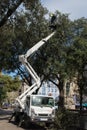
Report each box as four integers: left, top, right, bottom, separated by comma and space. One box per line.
33, 12, 72, 107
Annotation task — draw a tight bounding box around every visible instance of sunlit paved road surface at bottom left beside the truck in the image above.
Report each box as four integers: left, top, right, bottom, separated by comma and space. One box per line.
0, 109, 47, 130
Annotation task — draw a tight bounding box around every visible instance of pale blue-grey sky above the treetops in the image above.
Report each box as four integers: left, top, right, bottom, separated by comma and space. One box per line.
41, 0, 87, 20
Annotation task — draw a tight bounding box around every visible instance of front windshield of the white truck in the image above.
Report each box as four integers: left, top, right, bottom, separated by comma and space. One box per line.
31, 96, 54, 107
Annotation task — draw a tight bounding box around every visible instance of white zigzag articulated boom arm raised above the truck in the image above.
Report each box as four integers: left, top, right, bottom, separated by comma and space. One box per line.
16, 32, 55, 109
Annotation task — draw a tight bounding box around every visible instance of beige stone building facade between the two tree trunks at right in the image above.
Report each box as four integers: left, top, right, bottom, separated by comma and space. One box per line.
64, 79, 79, 109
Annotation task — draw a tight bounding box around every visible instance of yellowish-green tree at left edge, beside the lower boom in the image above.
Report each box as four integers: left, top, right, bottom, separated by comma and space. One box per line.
0, 75, 21, 104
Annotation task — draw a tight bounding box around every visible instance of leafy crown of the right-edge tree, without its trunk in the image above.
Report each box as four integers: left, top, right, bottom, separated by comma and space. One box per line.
66, 19, 87, 76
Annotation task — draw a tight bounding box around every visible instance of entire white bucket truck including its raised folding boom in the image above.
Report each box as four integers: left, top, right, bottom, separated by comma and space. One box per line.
12, 14, 55, 125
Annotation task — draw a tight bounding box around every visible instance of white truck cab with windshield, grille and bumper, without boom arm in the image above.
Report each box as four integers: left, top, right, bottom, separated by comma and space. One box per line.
25, 95, 55, 123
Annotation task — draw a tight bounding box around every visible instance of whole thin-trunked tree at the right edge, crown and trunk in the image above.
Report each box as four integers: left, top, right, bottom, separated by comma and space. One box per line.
66, 18, 87, 110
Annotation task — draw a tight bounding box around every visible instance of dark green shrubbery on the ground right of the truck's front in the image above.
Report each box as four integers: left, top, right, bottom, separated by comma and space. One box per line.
54, 108, 79, 130
